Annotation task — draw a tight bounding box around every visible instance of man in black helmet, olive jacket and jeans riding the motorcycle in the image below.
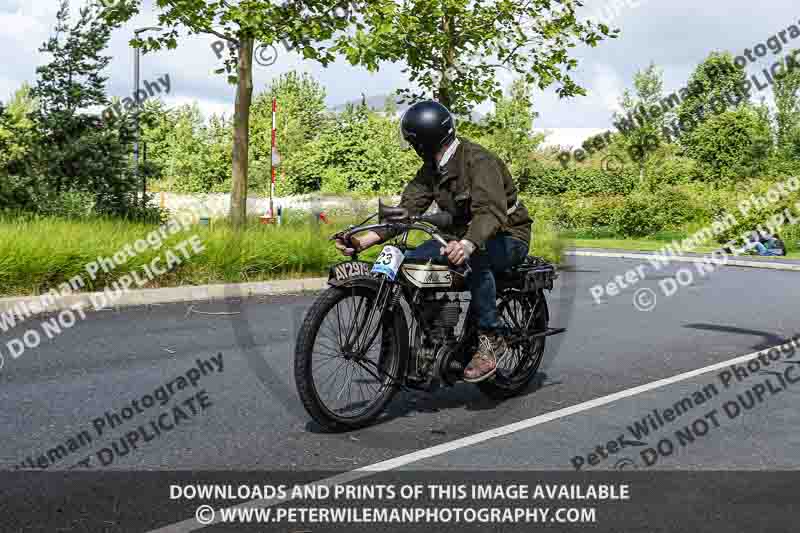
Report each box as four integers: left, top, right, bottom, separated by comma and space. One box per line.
336, 100, 532, 383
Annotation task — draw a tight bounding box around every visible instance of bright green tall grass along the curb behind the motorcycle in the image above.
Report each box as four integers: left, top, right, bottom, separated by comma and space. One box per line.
0, 211, 560, 296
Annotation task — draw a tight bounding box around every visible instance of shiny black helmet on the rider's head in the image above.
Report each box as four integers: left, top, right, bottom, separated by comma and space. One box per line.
400, 100, 456, 160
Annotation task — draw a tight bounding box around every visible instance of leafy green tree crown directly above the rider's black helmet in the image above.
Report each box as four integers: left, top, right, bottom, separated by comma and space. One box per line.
333, 0, 616, 114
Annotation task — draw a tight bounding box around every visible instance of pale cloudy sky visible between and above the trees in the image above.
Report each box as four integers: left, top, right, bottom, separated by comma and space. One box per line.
0, 0, 800, 146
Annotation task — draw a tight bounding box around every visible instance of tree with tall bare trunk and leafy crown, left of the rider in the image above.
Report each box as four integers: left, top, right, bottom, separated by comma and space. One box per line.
99, 0, 349, 227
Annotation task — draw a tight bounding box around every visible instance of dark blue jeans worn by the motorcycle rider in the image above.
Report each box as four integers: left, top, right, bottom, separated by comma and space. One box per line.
406, 233, 528, 333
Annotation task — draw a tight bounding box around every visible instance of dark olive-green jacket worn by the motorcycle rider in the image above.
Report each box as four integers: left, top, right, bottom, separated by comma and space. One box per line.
381, 139, 533, 248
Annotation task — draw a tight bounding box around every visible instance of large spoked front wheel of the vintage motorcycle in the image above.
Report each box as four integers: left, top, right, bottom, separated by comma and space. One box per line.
294, 286, 408, 431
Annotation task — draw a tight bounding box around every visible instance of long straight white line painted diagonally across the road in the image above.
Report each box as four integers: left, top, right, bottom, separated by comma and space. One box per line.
149, 340, 800, 533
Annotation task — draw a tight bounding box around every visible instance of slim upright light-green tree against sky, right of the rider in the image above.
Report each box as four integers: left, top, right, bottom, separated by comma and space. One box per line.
615, 63, 665, 182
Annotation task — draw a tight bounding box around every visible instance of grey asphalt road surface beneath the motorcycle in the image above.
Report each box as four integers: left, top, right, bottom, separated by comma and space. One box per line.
0, 254, 800, 471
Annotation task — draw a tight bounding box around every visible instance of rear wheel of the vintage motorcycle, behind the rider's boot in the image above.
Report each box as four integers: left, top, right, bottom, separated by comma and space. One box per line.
477, 291, 549, 400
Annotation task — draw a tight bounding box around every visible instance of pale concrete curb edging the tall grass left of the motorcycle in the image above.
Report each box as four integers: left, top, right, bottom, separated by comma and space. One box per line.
0, 278, 328, 316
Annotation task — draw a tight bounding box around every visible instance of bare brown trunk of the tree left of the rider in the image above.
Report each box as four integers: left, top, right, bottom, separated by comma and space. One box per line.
230, 37, 253, 228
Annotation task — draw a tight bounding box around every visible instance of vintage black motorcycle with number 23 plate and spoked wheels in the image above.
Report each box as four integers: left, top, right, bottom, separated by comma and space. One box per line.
294, 203, 564, 431
